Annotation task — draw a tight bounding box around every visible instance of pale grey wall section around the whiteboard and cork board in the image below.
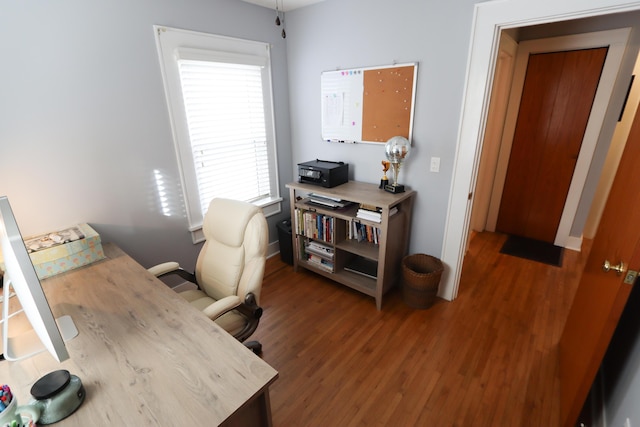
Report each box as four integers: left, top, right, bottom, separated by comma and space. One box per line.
287, 0, 484, 256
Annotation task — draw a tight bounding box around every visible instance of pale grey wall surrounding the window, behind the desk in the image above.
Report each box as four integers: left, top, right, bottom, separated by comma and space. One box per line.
0, 0, 292, 267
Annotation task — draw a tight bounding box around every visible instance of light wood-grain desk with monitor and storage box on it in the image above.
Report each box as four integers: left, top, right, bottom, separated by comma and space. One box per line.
0, 245, 278, 426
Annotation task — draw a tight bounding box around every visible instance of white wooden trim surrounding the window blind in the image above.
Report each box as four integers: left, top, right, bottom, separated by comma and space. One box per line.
153, 25, 282, 243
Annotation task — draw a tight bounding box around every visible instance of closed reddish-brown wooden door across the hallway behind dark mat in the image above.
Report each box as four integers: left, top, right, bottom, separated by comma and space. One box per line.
496, 47, 607, 243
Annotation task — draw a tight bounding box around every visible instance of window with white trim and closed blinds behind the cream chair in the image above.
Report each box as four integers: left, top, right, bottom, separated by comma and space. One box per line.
154, 26, 281, 242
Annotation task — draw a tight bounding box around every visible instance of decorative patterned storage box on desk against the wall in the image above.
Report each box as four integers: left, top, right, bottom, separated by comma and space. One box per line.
25, 224, 105, 279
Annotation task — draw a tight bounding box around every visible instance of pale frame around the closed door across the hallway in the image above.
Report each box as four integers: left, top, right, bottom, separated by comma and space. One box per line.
487, 28, 631, 247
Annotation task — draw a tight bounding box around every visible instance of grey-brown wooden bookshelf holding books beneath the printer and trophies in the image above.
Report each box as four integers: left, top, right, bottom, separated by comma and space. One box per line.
287, 181, 416, 310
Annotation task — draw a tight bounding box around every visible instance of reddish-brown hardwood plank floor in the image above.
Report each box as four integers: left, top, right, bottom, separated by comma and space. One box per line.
252, 233, 588, 427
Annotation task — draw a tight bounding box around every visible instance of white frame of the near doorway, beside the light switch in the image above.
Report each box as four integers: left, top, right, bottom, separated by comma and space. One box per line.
438, 0, 640, 301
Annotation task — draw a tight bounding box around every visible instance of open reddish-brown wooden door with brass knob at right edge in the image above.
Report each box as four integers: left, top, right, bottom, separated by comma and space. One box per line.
558, 98, 640, 426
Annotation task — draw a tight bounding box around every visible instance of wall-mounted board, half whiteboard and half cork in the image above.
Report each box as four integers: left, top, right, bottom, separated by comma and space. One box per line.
320, 63, 418, 144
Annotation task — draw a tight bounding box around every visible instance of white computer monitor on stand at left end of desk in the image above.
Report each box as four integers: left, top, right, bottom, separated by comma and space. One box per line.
0, 196, 78, 362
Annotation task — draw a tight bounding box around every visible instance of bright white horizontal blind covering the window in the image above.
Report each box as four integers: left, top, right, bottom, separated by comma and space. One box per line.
178, 60, 270, 214
